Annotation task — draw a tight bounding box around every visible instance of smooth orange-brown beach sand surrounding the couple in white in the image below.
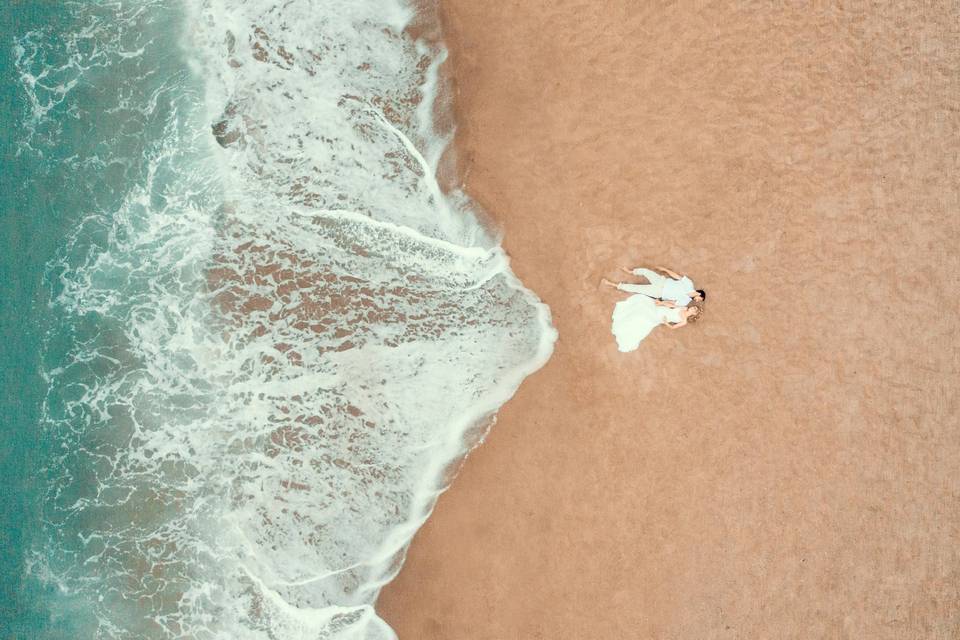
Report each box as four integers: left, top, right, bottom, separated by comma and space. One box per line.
378, 0, 960, 640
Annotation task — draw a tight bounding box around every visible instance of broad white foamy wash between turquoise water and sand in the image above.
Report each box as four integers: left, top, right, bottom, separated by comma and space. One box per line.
37, 0, 555, 640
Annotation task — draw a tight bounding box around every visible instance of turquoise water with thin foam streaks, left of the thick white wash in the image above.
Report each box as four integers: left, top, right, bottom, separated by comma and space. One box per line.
0, 1, 201, 639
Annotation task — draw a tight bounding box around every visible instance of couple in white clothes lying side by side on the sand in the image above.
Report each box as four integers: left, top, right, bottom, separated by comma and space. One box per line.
601, 267, 707, 351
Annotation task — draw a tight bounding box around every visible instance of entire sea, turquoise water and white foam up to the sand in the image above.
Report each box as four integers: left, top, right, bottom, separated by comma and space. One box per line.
0, 0, 555, 639
